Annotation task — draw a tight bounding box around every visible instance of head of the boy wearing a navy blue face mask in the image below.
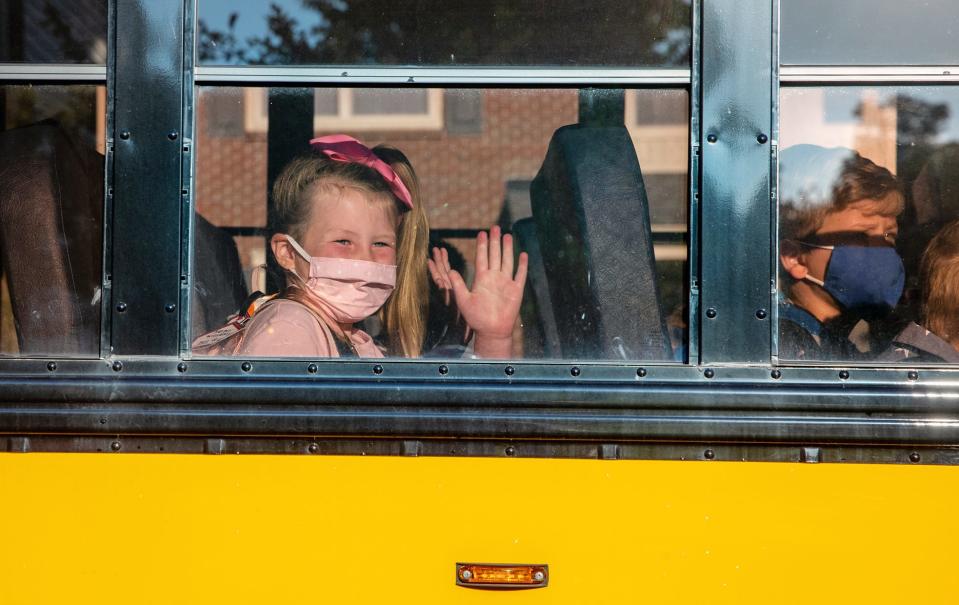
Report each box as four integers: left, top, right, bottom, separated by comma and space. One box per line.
779, 145, 903, 321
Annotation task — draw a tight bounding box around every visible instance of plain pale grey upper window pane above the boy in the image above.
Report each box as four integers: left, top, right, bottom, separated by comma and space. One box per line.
780, 0, 959, 65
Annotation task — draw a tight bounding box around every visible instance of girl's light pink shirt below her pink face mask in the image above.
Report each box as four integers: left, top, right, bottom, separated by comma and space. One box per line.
235, 298, 383, 357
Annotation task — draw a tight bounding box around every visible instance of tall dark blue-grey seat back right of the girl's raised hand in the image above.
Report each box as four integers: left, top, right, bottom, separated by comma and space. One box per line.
530, 124, 672, 360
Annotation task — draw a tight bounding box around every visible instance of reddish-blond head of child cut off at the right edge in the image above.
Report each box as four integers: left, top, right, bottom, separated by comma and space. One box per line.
920, 221, 959, 349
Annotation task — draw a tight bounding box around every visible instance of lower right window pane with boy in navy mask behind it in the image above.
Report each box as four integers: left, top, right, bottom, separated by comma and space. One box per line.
779, 86, 959, 363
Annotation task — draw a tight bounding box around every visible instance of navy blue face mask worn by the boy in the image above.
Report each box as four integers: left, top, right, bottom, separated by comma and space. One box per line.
805, 244, 906, 319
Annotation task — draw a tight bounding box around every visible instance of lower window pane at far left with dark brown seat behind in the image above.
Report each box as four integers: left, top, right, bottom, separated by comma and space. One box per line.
0, 85, 106, 357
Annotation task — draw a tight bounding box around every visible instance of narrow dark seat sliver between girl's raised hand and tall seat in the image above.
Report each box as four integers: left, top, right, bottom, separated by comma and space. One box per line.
512, 217, 562, 358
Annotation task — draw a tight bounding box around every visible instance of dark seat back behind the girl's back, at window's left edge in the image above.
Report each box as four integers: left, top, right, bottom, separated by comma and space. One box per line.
191, 213, 247, 337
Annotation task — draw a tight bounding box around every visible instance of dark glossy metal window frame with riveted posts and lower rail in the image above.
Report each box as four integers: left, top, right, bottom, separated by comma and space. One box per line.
0, 0, 959, 458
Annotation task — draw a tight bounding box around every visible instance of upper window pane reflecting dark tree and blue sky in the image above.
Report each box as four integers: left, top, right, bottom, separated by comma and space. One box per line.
198, 0, 690, 67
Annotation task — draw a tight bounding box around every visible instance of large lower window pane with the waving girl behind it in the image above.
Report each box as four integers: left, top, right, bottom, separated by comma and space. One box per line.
194, 87, 689, 361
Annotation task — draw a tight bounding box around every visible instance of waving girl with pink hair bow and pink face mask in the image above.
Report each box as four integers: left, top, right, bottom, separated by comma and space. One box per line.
236, 135, 527, 358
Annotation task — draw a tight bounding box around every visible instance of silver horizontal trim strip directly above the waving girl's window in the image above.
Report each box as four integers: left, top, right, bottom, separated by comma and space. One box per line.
196, 65, 690, 86
